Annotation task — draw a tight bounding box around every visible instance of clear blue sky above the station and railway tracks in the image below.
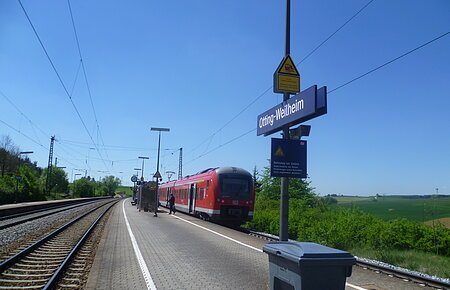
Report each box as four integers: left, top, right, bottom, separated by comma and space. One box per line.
0, 0, 450, 195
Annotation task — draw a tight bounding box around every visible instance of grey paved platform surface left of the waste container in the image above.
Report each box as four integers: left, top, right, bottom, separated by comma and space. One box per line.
86, 199, 269, 289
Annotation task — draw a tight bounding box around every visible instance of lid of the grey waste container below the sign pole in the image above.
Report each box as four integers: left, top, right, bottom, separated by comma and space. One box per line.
263, 242, 356, 265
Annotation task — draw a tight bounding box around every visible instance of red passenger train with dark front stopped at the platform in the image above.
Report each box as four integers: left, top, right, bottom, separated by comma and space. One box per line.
159, 167, 255, 225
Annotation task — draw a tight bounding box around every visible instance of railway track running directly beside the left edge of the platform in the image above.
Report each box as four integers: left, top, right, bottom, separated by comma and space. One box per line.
0, 201, 116, 289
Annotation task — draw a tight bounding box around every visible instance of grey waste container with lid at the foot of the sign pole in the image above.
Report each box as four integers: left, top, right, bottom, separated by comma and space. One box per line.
263, 242, 356, 290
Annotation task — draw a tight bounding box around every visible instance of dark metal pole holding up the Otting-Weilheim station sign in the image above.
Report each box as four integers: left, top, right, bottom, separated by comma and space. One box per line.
280, 0, 291, 241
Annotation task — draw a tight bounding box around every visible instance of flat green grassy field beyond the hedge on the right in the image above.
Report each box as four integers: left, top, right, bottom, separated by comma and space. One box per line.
334, 196, 450, 223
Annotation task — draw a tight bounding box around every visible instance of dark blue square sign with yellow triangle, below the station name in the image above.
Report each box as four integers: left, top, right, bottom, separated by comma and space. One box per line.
270, 138, 306, 178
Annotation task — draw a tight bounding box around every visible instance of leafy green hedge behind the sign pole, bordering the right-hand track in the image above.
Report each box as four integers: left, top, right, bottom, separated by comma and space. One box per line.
248, 197, 450, 256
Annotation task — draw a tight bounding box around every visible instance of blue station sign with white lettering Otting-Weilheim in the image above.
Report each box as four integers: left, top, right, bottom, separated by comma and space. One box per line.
256, 85, 327, 136
